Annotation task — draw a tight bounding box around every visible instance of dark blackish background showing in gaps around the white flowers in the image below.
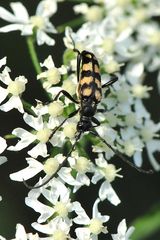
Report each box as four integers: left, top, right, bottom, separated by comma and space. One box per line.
0, 0, 160, 240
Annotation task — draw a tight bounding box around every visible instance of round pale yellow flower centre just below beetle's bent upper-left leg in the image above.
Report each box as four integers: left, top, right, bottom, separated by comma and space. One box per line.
48, 101, 64, 117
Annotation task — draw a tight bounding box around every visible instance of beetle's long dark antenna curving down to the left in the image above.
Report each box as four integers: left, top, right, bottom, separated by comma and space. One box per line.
23, 132, 81, 189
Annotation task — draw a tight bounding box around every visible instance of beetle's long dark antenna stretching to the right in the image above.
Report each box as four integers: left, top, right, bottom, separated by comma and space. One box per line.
91, 131, 153, 174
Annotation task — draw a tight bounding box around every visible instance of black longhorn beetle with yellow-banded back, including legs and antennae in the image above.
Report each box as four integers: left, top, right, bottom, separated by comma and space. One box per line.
23, 38, 152, 189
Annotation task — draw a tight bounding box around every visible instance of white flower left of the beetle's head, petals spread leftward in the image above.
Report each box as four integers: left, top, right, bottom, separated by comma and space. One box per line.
8, 113, 55, 158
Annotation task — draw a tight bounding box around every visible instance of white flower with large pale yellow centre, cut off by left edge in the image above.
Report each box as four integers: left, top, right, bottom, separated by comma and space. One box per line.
0, 67, 28, 113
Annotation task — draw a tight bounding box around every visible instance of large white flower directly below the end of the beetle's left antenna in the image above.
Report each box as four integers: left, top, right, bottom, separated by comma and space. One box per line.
25, 178, 79, 223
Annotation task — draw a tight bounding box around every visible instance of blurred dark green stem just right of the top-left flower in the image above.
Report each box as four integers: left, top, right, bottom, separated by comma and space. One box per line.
57, 16, 84, 33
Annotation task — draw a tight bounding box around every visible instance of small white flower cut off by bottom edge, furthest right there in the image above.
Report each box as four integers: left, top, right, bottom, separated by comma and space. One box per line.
112, 219, 134, 240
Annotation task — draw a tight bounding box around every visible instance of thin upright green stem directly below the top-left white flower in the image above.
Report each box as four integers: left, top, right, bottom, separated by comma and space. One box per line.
27, 36, 41, 74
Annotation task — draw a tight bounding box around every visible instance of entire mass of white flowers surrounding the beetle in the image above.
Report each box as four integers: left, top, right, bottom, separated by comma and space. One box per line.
0, 0, 160, 240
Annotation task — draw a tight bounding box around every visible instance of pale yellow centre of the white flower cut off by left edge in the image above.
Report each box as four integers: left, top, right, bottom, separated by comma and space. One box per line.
7, 76, 25, 96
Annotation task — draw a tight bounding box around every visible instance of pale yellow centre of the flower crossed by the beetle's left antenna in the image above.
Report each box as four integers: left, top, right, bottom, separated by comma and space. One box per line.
43, 158, 59, 176
